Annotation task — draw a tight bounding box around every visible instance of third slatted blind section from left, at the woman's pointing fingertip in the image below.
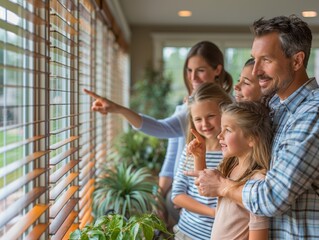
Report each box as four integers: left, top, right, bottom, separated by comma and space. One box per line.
79, 0, 96, 228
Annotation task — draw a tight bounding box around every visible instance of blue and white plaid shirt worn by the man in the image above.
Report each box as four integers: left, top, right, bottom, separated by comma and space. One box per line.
242, 78, 319, 240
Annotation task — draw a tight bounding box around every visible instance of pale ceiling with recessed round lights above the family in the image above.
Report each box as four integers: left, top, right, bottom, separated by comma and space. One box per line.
119, 0, 319, 26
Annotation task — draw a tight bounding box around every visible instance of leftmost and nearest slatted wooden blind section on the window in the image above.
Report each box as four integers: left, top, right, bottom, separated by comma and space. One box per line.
0, 0, 49, 239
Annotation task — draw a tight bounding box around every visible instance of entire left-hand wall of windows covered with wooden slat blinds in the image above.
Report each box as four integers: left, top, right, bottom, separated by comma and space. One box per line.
0, 0, 128, 240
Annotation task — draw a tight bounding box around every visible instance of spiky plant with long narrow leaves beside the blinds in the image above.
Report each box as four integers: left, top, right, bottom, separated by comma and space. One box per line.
93, 162, 160, 218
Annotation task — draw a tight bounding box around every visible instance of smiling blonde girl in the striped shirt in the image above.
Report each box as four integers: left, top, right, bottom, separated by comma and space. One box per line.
172, 83, 232, 240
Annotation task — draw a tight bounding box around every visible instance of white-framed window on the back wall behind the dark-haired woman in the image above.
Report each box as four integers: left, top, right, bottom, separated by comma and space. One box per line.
159, 33, 319, 106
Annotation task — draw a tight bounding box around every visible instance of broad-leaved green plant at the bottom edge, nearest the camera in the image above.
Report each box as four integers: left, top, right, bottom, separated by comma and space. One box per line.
69, 214, 172, 240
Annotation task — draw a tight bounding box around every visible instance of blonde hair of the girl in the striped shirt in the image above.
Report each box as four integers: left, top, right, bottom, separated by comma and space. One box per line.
187, 82, 232, 143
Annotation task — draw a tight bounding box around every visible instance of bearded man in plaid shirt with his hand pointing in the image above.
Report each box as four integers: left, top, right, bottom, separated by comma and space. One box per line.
186, 15, 319, 240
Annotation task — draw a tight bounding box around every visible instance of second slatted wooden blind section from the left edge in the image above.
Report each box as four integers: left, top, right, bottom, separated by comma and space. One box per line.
49, 0, 79, 239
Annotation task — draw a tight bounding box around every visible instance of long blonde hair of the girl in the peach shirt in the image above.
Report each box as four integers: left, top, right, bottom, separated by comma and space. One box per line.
219, 101, 272, 185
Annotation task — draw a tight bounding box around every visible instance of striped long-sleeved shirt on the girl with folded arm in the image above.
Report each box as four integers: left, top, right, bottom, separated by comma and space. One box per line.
172, 148, 223, 240
